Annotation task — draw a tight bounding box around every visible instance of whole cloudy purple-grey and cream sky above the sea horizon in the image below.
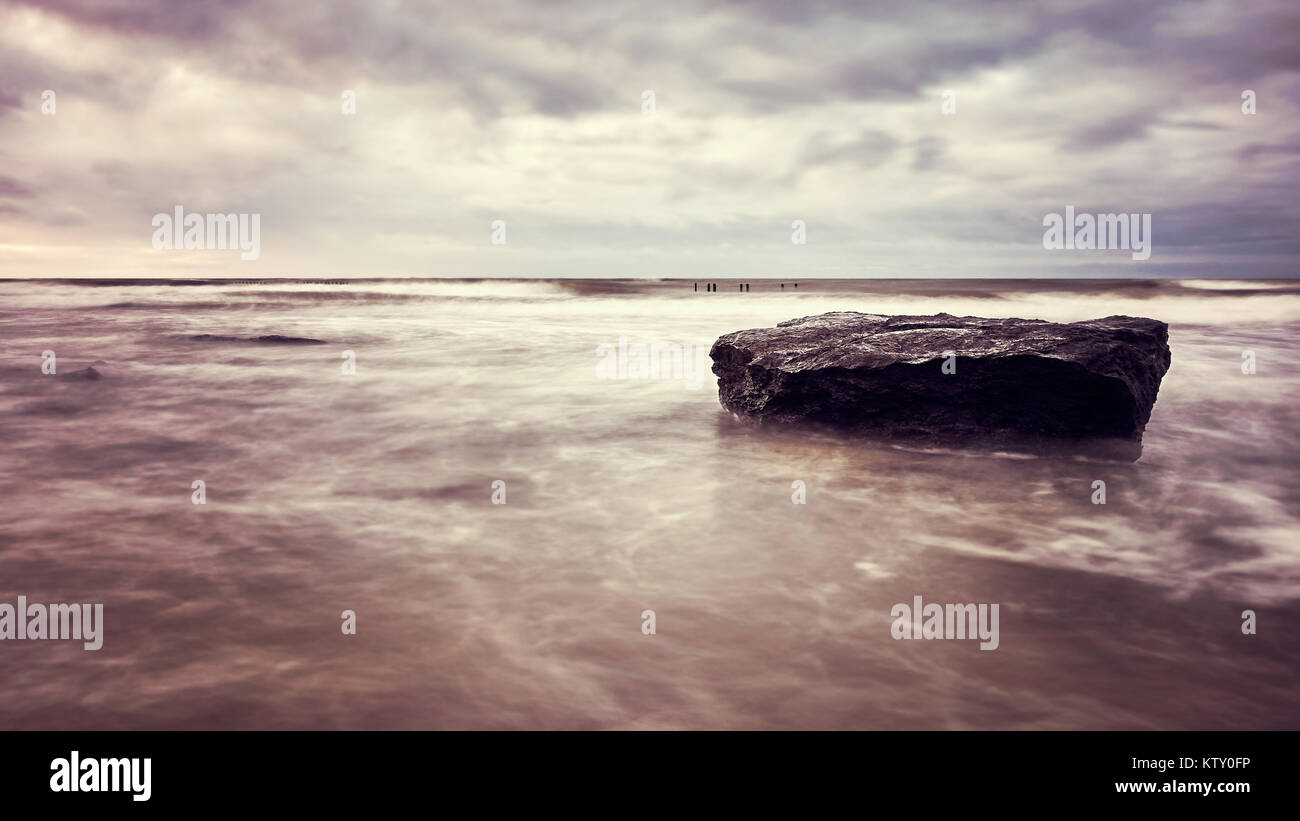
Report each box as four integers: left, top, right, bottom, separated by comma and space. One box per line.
0, 0, 1300, 277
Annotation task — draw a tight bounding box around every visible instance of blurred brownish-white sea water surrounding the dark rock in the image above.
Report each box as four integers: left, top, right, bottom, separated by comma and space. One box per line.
0, 281, 1300, 729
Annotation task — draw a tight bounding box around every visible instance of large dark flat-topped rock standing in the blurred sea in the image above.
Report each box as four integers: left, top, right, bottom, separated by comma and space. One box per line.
710, 312, 1170, 459
